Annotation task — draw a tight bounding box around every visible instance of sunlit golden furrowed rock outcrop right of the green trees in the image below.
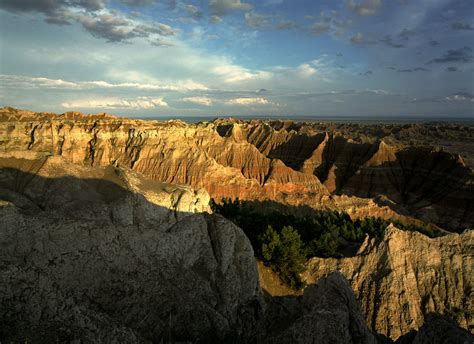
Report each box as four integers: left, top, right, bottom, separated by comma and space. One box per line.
304, 226, 474, 339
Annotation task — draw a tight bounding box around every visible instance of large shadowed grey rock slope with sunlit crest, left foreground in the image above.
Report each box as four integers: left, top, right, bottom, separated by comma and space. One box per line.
0, 157, 262, 343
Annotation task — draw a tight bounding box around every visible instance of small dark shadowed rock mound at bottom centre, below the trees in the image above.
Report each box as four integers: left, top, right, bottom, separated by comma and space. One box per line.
257, 273, 378, 344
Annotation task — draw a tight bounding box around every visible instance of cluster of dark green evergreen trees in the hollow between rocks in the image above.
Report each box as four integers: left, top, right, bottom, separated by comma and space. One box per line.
210, 199, 443, 289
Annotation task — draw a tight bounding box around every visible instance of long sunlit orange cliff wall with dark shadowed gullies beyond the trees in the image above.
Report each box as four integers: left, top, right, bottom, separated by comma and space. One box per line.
0, 108, 474, 231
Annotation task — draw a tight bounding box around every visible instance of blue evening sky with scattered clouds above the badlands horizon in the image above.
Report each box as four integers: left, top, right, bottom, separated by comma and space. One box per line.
0, 0, 474, 118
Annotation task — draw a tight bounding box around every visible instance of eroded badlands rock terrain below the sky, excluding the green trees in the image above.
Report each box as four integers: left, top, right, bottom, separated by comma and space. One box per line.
0, 108, 474, 343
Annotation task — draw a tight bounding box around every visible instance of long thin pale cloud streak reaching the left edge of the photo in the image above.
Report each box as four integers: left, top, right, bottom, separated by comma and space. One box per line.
0, 74, 208, 92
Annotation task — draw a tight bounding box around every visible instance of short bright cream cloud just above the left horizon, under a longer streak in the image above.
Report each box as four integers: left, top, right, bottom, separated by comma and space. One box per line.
61, 97, 168, 109
